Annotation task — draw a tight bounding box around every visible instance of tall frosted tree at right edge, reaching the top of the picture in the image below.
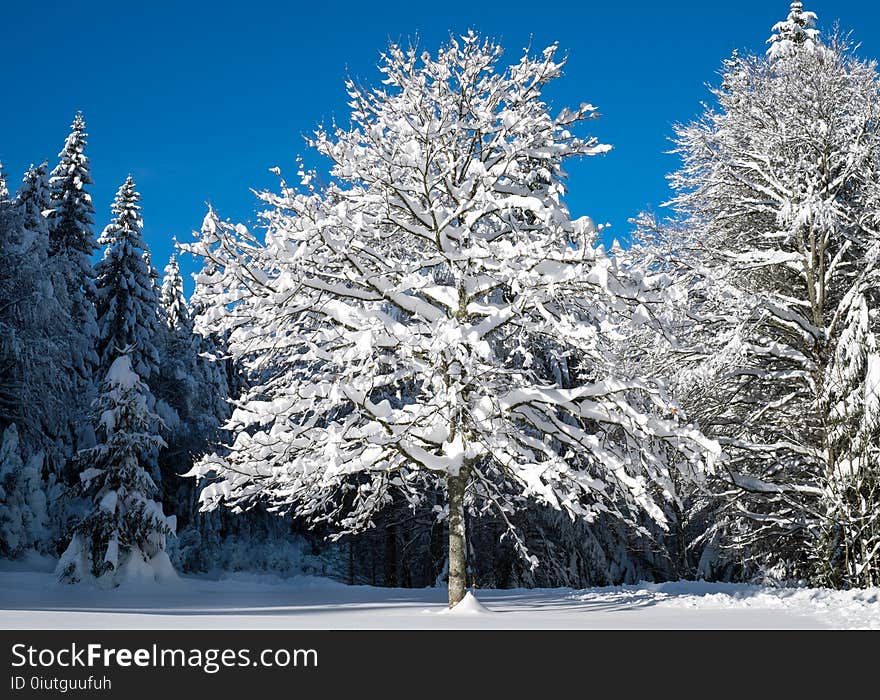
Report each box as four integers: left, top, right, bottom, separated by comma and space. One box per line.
643, 2, 880, 586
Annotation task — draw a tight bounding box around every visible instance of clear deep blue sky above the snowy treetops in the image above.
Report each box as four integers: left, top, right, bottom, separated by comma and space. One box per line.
0, 0, 880, 288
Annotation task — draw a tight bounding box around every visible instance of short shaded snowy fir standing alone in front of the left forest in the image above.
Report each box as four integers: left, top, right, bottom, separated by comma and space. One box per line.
57, 348, 175, 587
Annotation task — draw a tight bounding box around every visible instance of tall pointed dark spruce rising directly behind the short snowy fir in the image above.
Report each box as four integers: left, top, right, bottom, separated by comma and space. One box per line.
95, 175, 159, 381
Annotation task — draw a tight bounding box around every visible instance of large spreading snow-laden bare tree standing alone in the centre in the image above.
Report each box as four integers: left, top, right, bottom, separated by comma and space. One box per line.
191, 34, 713, 604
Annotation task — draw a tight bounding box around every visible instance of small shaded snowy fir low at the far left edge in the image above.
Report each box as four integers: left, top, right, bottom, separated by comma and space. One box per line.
0, 423, 47, 557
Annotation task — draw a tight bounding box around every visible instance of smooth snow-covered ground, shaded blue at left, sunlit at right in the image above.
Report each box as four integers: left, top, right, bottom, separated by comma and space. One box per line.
0, 561, 880, 629
